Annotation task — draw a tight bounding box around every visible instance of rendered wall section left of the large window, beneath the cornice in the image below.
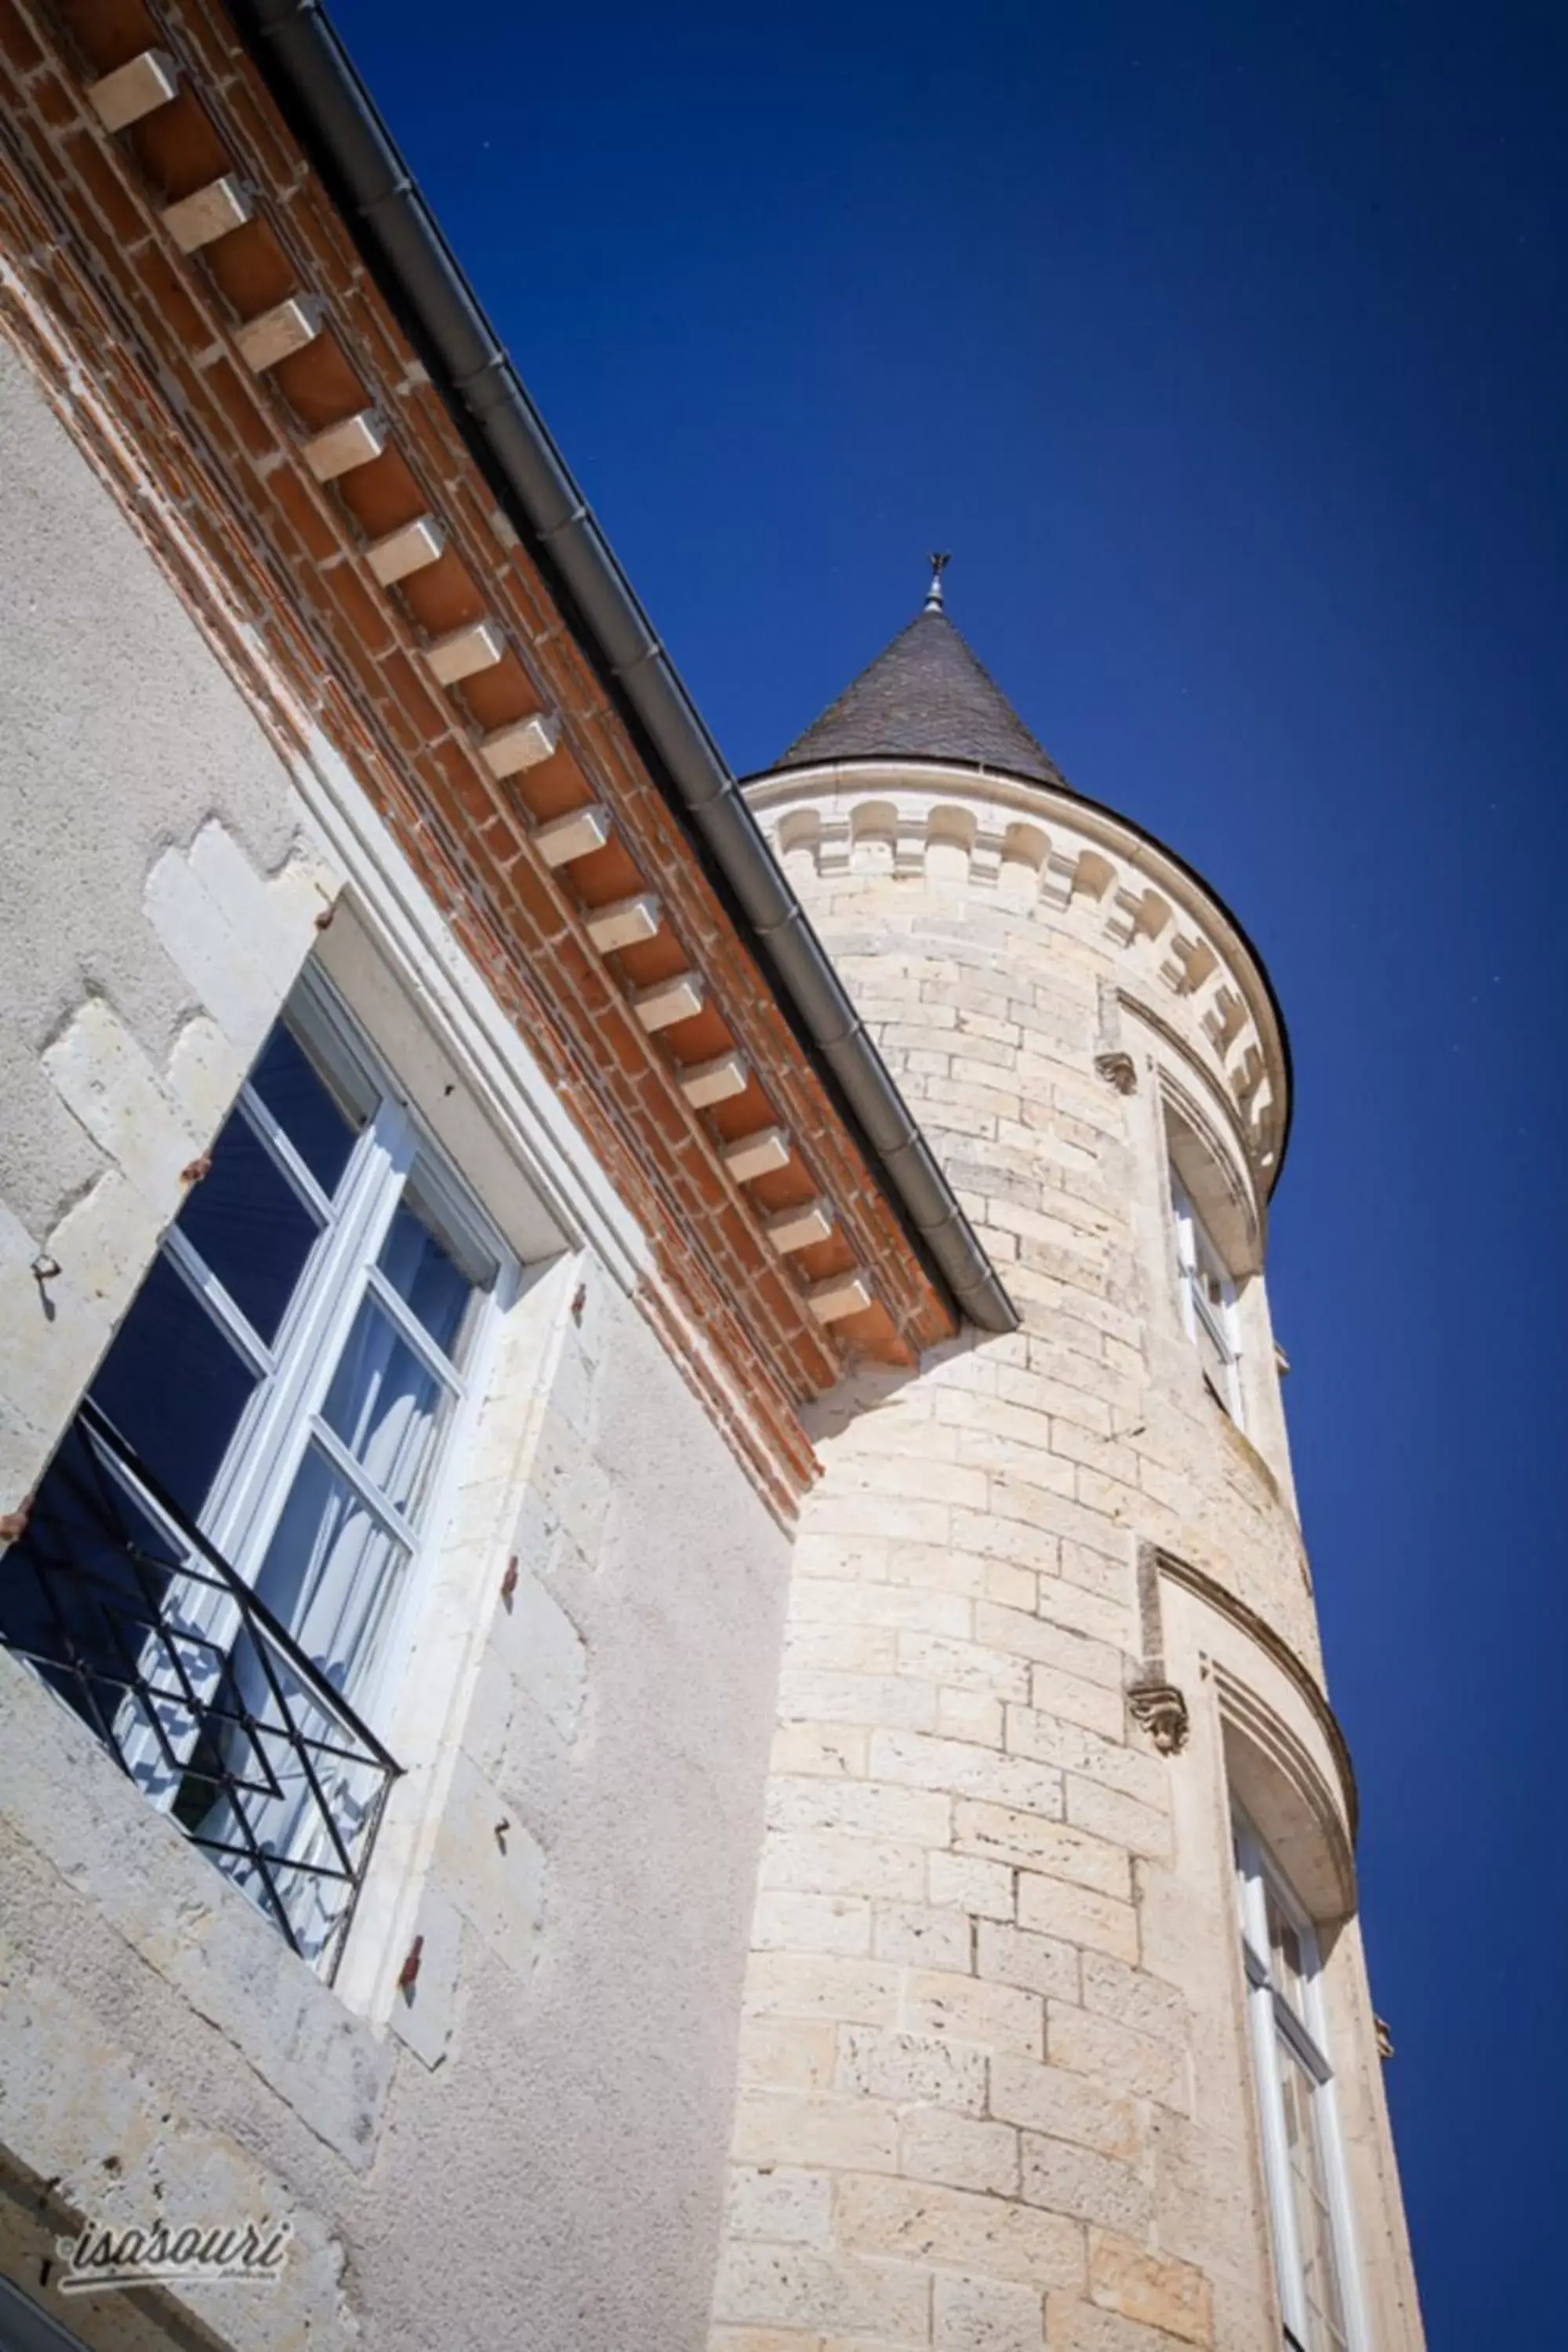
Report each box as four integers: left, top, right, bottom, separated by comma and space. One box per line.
0, 341, 339, 1512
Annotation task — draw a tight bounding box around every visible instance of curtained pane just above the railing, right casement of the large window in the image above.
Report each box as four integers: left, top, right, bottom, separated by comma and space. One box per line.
256, 1446, 407, 1691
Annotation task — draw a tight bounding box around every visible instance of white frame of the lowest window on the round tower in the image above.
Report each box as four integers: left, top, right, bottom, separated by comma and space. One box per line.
1232, 1806, 1370, 2352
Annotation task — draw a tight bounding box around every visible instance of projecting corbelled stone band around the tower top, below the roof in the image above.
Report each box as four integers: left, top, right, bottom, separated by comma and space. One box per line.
748, 760, 1288, 1197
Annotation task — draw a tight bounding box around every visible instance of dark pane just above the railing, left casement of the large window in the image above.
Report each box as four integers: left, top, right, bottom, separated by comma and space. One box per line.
92, 1256, 256, 1519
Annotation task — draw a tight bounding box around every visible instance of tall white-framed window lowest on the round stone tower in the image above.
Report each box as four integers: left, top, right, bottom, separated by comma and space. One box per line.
1234, 1811, 1366, 2352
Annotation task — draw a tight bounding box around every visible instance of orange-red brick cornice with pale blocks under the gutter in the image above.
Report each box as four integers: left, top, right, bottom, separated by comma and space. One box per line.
0, 0, 949, 1501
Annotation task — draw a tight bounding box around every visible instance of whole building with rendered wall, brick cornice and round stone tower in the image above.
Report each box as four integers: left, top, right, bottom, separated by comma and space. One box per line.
0, 0, 1420, 2352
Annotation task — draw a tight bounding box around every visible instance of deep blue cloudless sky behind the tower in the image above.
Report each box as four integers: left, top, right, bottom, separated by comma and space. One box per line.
334, 13, 1568, 2352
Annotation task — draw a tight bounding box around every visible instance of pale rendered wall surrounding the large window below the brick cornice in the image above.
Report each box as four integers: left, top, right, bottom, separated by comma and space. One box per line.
0, 343, 787, 2352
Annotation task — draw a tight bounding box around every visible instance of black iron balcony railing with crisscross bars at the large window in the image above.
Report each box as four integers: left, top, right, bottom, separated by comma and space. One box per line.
0, 1402, 397, 1976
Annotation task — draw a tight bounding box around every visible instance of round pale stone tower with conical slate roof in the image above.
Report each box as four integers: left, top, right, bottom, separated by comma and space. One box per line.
715, 567, 1422, 2352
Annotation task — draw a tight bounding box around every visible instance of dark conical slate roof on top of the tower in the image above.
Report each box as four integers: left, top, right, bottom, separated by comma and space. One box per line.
779, 600, 1062, 786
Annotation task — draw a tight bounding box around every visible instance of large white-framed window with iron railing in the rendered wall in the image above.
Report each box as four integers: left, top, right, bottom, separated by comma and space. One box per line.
0, 974, 513, 1962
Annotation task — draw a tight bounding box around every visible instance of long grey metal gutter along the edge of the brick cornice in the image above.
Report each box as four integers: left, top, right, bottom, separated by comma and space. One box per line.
228, 0, 1018, 1331
